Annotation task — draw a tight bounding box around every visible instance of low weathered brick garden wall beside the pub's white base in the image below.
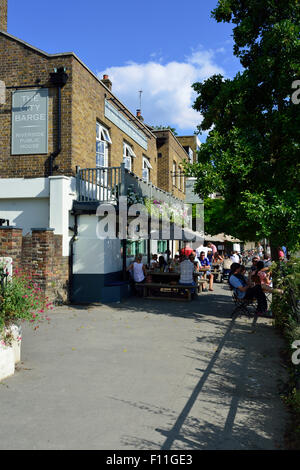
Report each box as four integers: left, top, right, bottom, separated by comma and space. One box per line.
0, 227, 69, 302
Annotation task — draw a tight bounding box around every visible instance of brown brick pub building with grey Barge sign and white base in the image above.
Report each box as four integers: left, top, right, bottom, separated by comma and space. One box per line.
0, 0, 202, 301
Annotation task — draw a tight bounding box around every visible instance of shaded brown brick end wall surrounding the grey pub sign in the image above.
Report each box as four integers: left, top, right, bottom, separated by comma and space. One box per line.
0, 33, 72, 178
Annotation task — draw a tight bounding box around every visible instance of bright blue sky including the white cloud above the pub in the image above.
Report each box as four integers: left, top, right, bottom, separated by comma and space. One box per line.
8, 0, 240, 140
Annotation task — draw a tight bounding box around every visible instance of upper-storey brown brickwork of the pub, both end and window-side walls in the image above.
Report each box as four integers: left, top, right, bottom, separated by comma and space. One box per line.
0, 31, 157, 184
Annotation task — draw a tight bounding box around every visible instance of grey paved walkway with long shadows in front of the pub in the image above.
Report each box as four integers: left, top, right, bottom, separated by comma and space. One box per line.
0, 285, 287, 450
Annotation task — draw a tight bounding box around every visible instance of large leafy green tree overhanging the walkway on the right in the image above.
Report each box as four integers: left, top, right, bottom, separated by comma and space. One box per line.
188, 0, 300, 253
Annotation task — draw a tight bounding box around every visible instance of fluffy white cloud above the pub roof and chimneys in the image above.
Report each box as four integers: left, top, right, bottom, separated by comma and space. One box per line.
98, 49, 224, 133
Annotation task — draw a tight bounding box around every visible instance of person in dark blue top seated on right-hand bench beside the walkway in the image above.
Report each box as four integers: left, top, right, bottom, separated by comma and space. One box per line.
229, 263, 268, 315
